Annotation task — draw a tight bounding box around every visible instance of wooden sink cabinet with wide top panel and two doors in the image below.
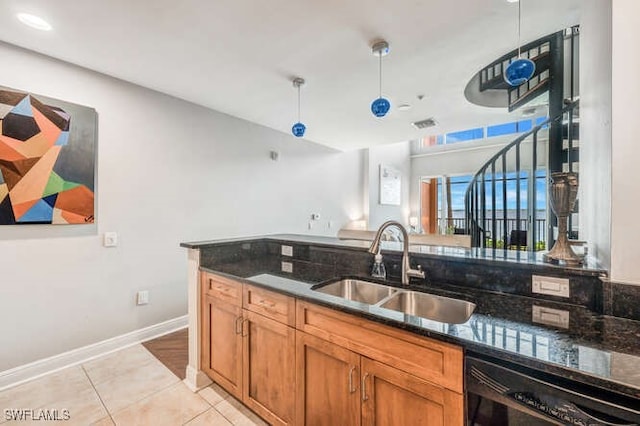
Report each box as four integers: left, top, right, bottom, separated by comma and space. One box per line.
296, 302, 464, 426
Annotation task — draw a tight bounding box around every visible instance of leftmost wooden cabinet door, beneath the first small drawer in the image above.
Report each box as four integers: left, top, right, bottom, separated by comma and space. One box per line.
202, 296, 242, 399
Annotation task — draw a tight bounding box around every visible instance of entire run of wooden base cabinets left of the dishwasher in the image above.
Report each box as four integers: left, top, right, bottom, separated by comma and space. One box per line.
202, 272, 464, 426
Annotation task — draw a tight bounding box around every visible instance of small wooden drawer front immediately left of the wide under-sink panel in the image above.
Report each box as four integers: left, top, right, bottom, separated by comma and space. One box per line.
243, 284, 296, 327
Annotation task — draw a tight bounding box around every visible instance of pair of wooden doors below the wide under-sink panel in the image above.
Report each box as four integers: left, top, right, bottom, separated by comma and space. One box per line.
296, 332, 463, 426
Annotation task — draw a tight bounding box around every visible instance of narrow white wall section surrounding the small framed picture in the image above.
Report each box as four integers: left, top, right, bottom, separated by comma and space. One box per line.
365, 142, 411, 230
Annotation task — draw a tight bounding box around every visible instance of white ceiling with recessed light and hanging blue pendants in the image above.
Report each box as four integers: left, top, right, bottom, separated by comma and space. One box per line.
0, 0, 580, 150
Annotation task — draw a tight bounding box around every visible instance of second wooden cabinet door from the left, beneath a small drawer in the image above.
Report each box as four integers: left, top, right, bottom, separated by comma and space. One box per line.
243, 309, 296, 425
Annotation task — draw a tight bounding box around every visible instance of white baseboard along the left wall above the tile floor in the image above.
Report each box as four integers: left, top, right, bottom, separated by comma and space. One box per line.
0, 315, 189, 391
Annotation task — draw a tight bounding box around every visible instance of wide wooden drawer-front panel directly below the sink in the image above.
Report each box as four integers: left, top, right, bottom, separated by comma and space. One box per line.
296, 301, 463, 393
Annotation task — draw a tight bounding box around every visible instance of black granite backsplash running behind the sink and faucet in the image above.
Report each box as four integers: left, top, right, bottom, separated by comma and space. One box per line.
200, 239, 616, 319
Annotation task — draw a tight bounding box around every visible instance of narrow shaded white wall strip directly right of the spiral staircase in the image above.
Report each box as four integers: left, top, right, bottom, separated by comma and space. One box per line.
579, 0, 612, 269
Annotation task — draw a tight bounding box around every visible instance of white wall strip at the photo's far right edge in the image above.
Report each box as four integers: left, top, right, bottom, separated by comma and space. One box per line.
611, 0, 640, 284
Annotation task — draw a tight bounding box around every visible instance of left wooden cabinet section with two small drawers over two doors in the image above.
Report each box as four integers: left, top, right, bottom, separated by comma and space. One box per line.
201, 272, 296, 425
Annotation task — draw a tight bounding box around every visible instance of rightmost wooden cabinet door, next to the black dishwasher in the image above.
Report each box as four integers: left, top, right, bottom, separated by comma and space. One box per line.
361, 357, 463, 426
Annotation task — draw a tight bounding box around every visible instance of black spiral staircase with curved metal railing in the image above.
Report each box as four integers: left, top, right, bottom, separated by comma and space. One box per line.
465, 26, 579, 251
